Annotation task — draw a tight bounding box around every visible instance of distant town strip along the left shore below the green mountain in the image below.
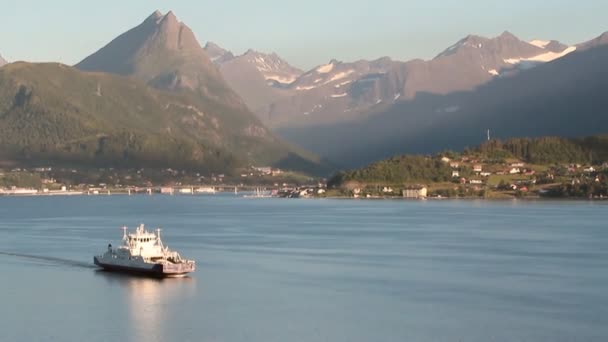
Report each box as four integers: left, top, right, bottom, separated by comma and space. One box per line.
0, 166, 325, 197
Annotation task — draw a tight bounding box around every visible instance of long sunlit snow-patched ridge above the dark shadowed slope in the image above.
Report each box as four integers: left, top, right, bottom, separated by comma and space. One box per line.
259, 32, 576, 129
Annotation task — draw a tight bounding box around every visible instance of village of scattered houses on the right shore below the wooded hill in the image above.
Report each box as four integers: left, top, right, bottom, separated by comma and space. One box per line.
328, 155, 608, 199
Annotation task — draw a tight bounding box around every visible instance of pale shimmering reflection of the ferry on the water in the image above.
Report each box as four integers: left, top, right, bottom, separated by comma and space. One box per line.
95, 270, 196, 341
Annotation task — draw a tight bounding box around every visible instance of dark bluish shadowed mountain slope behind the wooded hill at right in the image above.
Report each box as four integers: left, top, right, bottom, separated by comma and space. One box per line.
279, 35, 608, 166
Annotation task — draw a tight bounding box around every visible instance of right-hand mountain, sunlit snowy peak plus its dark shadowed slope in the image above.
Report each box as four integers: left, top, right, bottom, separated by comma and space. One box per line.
276, 33, 608, 167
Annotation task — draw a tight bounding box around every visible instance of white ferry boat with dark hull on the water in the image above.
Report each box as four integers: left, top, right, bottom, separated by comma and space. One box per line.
93, 224, 196, 277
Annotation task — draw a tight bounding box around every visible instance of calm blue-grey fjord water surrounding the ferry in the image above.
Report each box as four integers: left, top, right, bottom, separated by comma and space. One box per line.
0, 195, 608, 341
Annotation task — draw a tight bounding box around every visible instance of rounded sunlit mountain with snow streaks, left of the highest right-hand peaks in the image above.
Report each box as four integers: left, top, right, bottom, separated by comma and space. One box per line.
262, 58, 403, 128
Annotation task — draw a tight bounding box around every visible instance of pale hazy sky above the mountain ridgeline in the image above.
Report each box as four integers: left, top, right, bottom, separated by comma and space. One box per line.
0, 0, 608, 68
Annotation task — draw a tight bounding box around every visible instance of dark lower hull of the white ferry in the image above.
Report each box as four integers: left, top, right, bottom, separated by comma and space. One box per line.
93, 256, 194, 278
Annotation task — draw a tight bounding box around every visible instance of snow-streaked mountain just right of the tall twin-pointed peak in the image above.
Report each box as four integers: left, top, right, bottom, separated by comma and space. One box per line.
205, 43, 302, 113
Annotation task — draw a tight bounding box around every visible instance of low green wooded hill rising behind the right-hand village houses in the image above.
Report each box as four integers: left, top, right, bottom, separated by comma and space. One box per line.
328, 136, 608, 187
